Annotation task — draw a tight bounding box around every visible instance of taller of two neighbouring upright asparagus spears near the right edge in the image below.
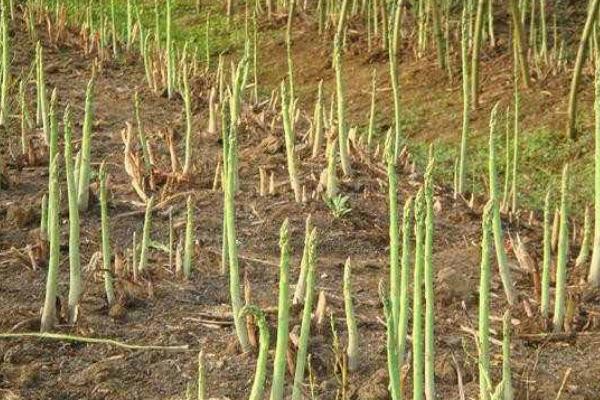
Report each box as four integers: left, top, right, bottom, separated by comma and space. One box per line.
552, 164, 569, 332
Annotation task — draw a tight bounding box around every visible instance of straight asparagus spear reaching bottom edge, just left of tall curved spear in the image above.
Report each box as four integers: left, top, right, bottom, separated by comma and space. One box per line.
478, 201, 494, 400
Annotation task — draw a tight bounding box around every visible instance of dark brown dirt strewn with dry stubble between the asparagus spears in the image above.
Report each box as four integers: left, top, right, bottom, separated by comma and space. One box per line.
0, 7, 600, 400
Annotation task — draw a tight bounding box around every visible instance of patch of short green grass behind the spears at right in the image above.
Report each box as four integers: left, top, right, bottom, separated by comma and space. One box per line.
409, 123, 594, 216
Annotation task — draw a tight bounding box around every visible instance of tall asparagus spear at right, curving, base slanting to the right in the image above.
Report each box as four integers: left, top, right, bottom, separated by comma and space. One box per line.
489, 104, 516, 305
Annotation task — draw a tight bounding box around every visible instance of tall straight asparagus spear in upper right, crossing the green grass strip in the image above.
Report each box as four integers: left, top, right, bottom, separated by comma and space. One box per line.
457, 6, 471, 194
